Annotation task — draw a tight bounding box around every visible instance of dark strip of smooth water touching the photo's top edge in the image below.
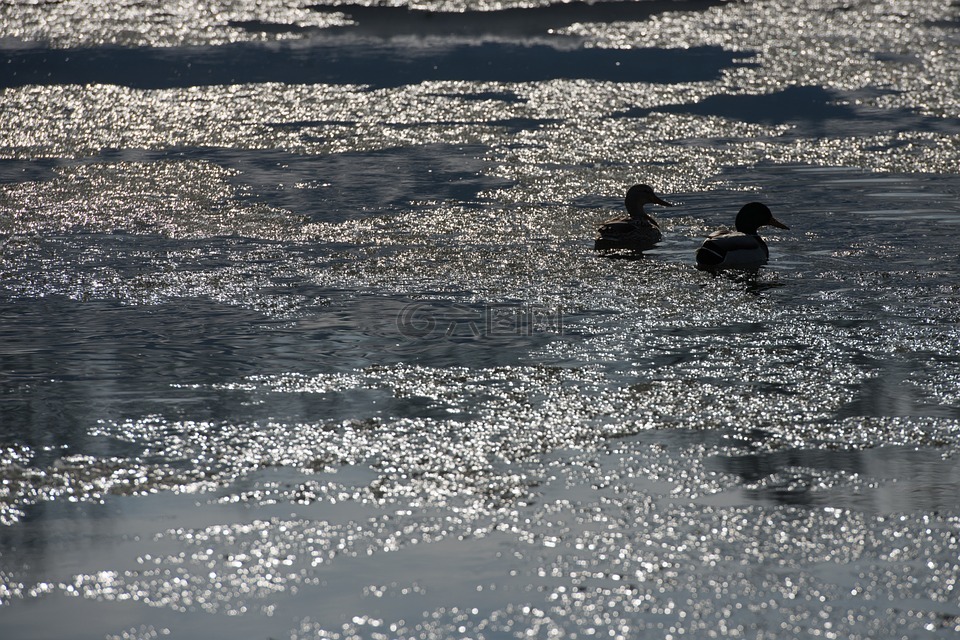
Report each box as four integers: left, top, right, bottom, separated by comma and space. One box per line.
310, 0, 723, 38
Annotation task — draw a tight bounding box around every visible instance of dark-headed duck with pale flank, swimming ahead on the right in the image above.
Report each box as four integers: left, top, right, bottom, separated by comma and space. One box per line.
697, 202, 790, 270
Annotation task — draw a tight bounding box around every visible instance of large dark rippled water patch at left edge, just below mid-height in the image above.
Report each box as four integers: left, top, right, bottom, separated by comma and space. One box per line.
0, 292, 564, 452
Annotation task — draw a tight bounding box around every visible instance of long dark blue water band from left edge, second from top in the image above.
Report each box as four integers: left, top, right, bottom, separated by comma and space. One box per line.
0, 40, 742, 89
